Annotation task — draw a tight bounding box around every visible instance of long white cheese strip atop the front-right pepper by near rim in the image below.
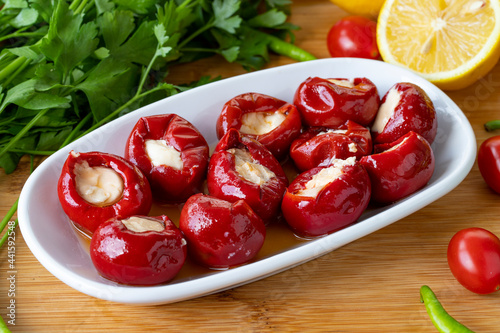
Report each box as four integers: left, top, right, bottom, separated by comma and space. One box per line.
296, 157, 356, 198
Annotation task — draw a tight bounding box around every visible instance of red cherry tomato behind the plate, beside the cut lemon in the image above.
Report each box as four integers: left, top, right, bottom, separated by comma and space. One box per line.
327, 16, 380, 59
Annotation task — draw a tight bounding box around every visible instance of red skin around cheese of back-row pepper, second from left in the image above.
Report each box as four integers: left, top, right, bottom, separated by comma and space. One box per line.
125, 114, 209, 203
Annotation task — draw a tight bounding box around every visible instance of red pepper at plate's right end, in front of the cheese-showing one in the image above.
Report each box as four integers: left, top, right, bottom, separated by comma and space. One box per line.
360, 132, 435, 204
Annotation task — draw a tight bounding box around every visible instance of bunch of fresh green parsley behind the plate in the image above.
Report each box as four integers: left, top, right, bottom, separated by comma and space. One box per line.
0, 0, 314, 246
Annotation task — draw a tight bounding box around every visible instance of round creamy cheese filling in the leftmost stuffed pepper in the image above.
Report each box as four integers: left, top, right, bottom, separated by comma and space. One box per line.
75, 161, 124, 206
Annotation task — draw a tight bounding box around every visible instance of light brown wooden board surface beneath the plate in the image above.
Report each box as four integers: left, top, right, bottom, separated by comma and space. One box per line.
0, 0, 500, 332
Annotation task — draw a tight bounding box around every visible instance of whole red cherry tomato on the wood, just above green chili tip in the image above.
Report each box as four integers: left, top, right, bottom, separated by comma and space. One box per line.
448, 228, 500, 294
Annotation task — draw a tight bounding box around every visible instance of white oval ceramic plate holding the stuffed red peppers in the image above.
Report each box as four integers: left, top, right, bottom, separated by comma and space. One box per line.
18, 58, 476, 304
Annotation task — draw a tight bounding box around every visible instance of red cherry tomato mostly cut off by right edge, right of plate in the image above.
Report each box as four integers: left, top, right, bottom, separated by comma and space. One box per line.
477, 135, 500, 193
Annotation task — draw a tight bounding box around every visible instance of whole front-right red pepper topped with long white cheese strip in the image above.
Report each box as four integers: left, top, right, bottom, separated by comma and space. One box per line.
281, 157, 371, 237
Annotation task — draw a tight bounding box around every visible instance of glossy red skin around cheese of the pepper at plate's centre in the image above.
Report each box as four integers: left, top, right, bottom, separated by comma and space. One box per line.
207, 129, 288, 222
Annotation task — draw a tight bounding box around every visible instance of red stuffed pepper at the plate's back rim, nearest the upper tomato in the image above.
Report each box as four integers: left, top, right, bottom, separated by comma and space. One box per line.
293, 77, 380, 127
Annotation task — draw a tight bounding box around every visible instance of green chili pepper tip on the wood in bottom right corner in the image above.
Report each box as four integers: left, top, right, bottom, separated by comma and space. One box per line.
420, 286, 474, 333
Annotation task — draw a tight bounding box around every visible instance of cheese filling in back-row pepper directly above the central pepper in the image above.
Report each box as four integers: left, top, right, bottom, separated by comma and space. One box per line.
240, 112, 286, 135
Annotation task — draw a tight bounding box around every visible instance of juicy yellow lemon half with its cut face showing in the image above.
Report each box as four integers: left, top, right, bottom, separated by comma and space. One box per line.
377, 0, 500, 90
